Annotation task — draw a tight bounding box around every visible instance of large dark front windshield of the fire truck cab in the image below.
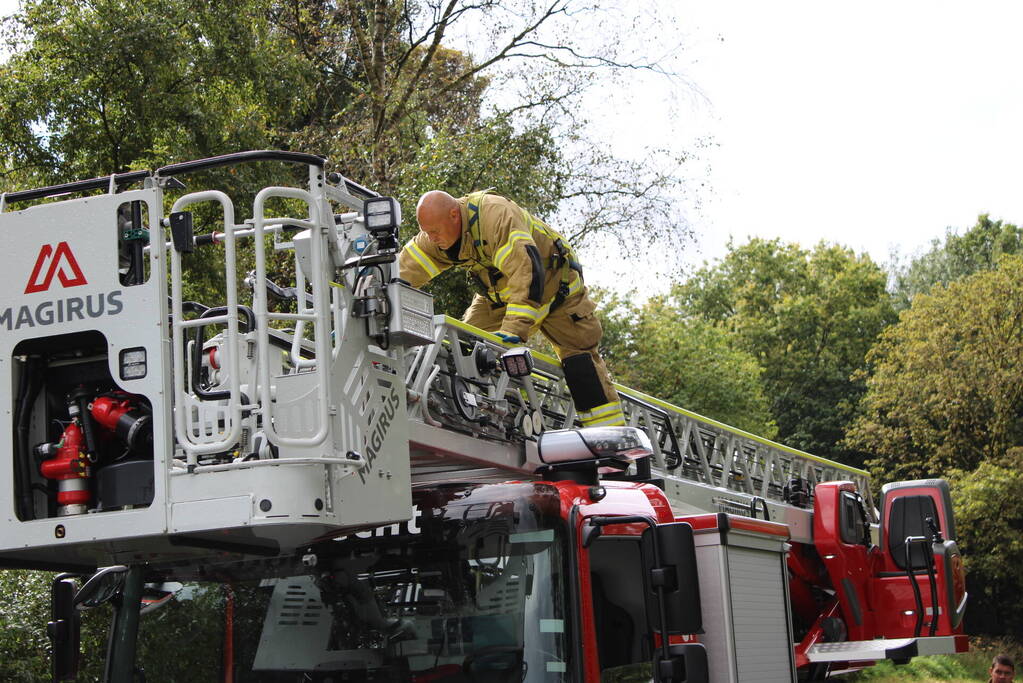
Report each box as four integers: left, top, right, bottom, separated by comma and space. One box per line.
131, 484, 570, 682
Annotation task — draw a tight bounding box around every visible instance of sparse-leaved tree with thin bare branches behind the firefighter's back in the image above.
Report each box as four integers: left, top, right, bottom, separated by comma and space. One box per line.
271, 0, 692, 308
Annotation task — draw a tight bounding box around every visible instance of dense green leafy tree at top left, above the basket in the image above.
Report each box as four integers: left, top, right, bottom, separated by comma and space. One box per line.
0, 0, 298, 183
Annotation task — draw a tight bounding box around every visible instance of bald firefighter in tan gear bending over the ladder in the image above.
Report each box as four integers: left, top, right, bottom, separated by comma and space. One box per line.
399, 190, 625, 426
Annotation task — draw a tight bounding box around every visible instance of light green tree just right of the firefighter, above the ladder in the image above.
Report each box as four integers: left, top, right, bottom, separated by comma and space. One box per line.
599, 294, 777, 439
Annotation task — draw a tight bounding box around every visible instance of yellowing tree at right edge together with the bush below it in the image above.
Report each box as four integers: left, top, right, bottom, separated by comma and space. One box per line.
848, 256, 1023, 633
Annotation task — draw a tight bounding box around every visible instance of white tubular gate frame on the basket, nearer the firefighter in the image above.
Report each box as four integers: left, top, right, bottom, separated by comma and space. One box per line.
253, 187, 332, 447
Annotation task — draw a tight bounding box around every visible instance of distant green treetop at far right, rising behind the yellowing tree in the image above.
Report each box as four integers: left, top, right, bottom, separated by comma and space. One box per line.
892, 214, 1023, 310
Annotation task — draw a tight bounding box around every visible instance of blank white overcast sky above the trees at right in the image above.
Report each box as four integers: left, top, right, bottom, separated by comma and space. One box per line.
0, 0, 1023, 288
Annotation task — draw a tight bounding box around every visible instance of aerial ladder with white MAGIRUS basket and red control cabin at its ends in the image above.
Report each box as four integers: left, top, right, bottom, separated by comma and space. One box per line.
0, 151, 966, 668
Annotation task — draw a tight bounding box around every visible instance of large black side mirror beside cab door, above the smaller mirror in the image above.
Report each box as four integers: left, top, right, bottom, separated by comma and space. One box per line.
641, 521, 703, 633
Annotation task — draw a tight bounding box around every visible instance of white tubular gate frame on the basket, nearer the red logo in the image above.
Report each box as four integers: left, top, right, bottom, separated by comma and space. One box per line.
170, 190, 241, 458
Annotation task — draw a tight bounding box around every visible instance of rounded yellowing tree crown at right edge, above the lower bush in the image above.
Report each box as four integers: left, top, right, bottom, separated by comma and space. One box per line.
848, 256, 1023, 479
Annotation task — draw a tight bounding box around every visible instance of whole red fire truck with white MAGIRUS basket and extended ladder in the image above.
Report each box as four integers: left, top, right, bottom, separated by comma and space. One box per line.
0, 151, 967, 682
